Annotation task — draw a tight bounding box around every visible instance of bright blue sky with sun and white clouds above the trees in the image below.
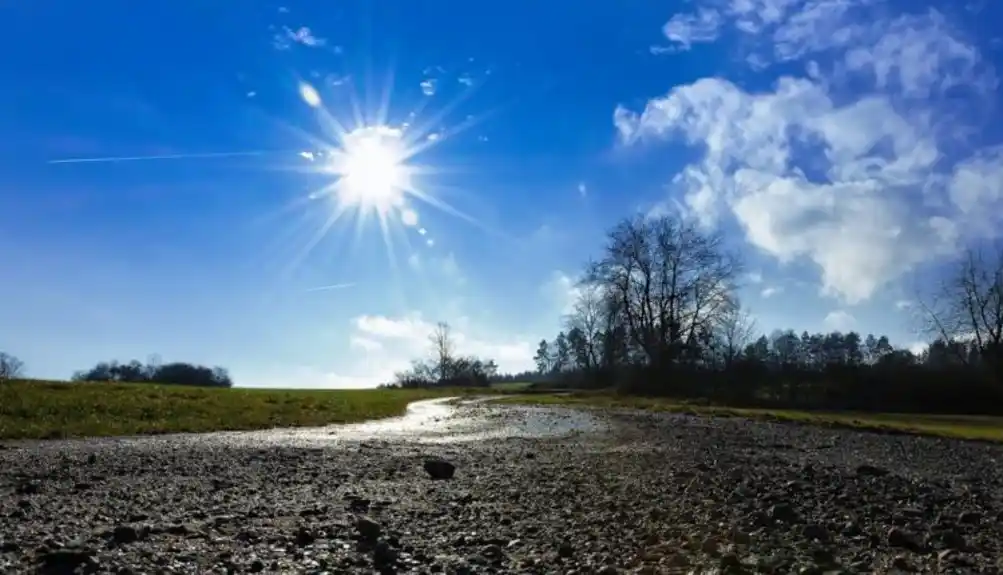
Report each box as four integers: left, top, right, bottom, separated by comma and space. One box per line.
0, 0, 1003, 387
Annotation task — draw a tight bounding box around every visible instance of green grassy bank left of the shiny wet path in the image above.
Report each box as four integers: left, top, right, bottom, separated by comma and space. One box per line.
0, 381, 464, 440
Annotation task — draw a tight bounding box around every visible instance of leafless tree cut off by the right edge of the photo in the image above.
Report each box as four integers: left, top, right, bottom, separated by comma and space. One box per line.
919, 248, 1003, 370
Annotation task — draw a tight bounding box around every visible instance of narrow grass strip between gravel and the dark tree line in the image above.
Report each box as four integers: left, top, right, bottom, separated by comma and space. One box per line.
497, 392, 1003, 442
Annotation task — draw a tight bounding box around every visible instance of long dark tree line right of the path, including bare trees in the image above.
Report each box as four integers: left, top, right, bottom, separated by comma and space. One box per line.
536, 216, 1003, 412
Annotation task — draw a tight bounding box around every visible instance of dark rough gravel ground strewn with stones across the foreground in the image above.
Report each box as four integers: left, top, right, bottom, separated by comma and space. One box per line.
0, 406, 1003, 574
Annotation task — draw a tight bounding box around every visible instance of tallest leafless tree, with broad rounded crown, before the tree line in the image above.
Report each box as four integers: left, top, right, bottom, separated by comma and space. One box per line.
589, 216, 741, 363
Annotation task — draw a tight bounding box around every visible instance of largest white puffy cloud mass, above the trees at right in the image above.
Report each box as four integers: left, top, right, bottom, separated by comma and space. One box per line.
614, 0, 1003, 303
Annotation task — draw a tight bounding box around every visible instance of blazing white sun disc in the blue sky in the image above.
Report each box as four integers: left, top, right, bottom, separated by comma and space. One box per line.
329, 125, 411, 215
